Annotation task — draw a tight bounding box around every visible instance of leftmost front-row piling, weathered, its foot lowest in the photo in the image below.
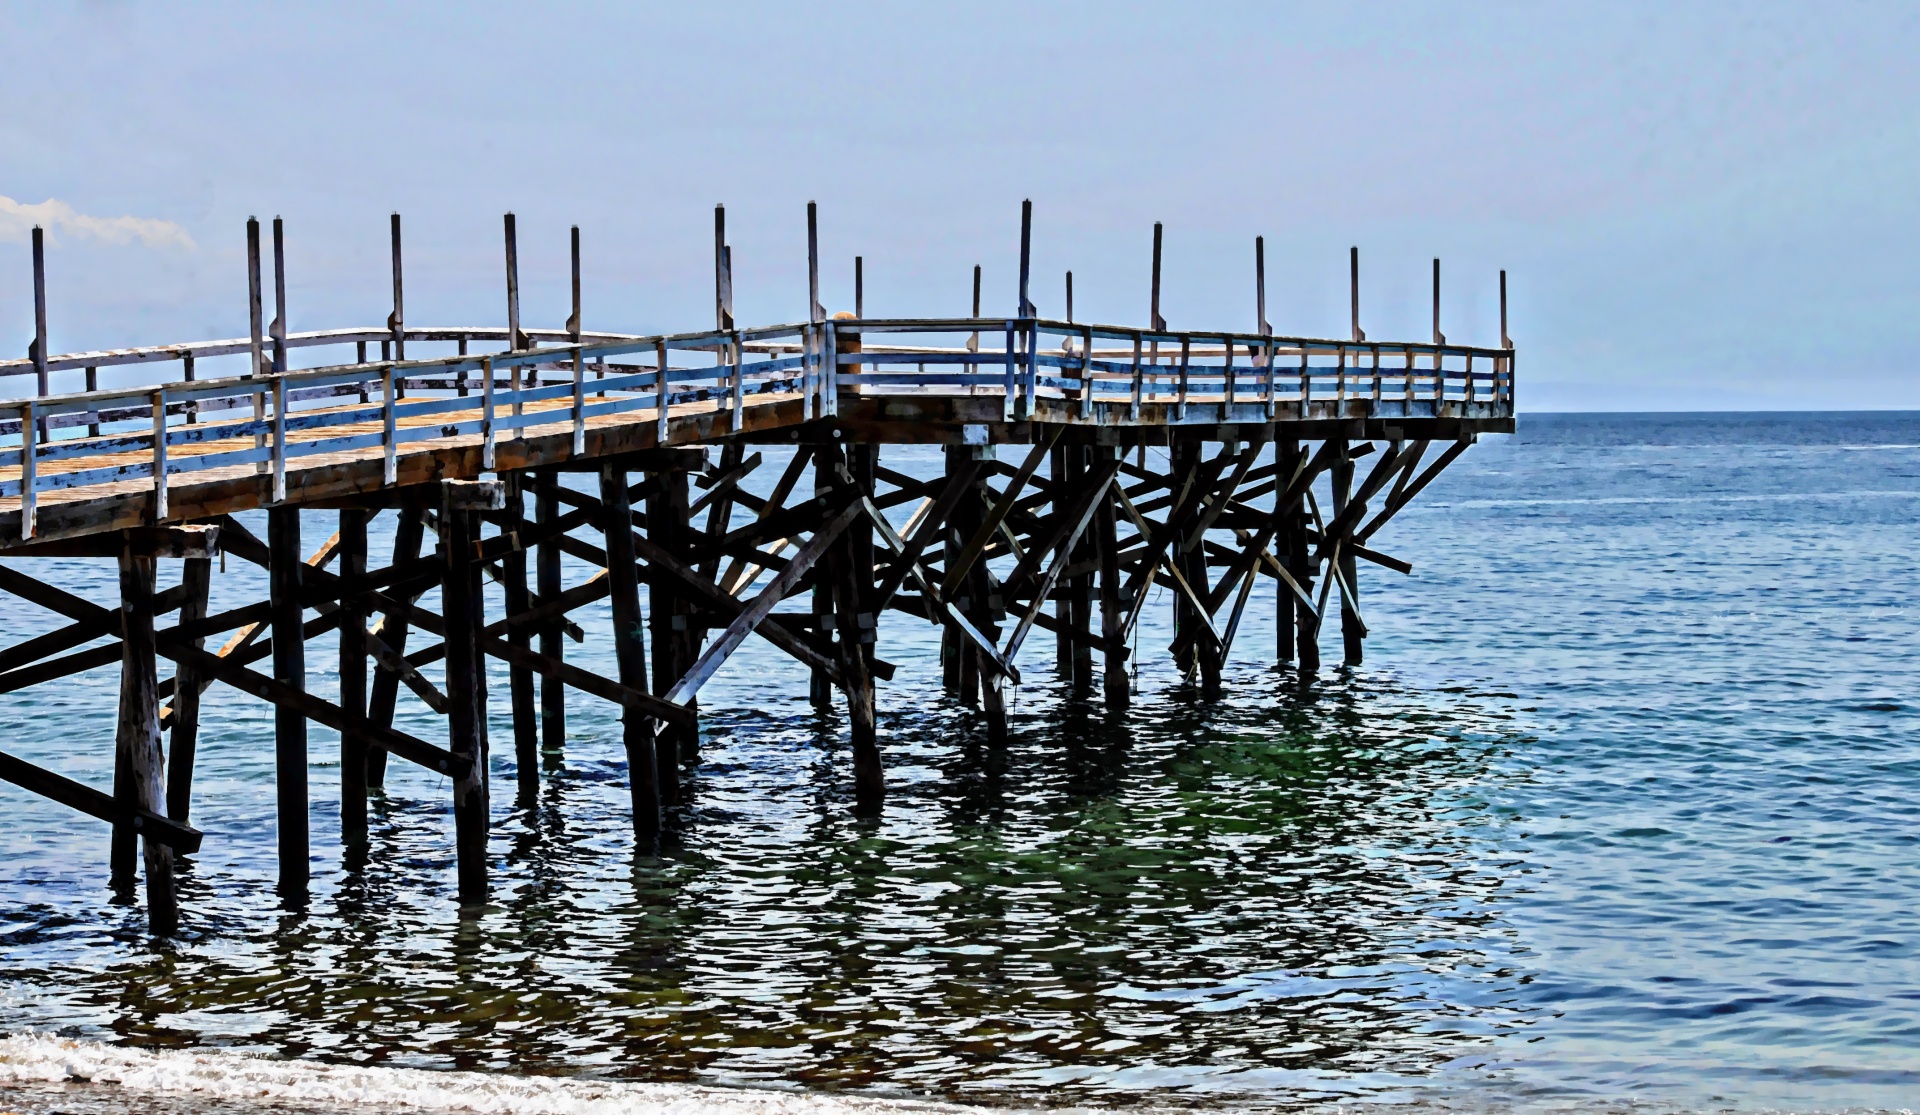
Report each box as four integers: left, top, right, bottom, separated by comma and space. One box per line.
113, 549, 180, 935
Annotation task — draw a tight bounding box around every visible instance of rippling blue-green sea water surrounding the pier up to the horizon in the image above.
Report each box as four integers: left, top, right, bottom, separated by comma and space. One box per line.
0, 415, 1920, 1115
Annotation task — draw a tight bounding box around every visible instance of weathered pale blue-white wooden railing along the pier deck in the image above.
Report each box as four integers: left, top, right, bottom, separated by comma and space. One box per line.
0, 319, 1513, 537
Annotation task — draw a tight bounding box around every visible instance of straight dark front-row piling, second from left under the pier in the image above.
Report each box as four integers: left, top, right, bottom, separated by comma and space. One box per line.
267, 505, 307, 900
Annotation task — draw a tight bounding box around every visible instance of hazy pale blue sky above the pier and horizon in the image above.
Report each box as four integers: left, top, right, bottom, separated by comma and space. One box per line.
0, 2, 1920, 411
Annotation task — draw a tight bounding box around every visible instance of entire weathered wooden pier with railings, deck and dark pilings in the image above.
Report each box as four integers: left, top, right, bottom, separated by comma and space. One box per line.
0, 205, 1513, 933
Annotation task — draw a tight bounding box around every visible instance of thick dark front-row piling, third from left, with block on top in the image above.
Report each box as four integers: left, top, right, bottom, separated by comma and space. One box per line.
440, 497, 490, 906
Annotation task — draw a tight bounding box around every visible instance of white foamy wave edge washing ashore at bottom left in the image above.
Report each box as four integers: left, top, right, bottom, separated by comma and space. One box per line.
0, 1034, 970, 1115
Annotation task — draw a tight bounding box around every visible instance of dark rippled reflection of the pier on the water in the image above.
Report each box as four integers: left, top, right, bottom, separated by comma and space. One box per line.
8, 666, 1530, 1103
